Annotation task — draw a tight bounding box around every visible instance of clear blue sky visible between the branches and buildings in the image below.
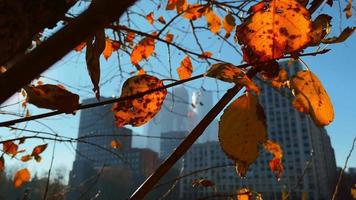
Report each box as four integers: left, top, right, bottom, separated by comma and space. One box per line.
0, 1, 356, 181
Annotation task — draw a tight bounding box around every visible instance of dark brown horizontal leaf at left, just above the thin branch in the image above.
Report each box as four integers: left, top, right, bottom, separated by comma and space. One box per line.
24, 84, 79, 113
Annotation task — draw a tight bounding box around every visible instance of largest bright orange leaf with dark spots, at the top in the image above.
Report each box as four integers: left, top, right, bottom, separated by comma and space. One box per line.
236, 0, 312, 63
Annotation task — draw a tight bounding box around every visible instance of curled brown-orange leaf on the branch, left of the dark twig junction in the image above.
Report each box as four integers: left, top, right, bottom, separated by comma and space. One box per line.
205, 63, 260, 94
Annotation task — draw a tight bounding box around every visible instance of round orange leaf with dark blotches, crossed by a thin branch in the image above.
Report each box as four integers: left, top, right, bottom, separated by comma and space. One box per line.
113, 74, 167, 127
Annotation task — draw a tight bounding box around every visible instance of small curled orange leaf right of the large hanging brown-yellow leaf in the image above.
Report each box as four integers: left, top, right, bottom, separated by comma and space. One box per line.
263, 140, 283, 180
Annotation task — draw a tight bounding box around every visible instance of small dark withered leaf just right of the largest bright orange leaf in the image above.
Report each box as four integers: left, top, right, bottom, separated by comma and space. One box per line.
311, 14, 332, 46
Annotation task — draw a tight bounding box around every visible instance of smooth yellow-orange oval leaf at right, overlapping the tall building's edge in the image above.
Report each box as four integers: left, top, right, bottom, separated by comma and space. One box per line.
290, 71, 334, 126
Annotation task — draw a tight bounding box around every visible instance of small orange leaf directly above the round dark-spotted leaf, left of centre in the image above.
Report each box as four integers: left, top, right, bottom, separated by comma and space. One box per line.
131, 37, 155, 65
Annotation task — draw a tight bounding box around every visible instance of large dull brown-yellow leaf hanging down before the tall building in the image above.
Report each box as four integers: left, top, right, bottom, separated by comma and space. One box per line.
219, 93, 267, 176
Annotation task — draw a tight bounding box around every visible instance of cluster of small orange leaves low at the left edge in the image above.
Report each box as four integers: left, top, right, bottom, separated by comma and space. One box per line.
0, 141, 47, 188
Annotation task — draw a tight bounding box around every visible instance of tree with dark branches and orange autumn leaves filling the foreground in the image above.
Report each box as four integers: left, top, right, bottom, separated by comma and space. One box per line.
0, 0, 355, 199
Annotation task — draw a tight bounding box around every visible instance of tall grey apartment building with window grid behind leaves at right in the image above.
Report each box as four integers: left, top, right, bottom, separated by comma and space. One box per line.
180, 63, 336, 200
